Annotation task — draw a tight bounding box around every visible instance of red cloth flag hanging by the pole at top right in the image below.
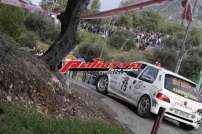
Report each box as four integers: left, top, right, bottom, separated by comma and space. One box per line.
182, 0, 192, 21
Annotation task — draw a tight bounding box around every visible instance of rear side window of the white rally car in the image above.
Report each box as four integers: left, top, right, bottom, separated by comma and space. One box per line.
139, 66, 159, 83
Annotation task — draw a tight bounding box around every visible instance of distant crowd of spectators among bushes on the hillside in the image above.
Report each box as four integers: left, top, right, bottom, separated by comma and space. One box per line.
80, 23, 168, 49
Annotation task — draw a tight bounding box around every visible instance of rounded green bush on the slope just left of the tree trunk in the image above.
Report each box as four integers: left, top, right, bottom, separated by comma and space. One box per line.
24, 13, 59, 43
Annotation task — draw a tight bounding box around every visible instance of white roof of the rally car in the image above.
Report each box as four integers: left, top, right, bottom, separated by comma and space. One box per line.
136, 61, 196, 85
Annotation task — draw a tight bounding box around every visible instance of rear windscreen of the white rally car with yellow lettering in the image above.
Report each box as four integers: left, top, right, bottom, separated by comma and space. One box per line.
164, 74, 201, 102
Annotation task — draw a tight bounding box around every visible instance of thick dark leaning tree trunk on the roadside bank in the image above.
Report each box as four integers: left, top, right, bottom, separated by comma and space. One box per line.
42, 0, 89, 70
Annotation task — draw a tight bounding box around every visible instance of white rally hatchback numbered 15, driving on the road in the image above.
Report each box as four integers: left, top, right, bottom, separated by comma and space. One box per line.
96, 62, 202, 129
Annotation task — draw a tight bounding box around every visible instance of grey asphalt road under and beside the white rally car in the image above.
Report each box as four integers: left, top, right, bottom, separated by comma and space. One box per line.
70, 81, 202, 134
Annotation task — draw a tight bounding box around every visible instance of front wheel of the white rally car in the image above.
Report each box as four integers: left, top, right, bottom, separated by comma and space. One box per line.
96, 76, 108, 94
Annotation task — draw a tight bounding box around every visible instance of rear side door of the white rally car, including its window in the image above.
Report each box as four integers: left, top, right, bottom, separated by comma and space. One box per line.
129, 66, 159, 103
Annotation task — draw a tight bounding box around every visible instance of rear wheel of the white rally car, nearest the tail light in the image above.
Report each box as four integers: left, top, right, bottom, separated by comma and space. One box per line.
137, 95, 151, 118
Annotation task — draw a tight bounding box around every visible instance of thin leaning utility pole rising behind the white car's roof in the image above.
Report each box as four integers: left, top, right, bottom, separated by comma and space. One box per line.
175, 0, 198, 73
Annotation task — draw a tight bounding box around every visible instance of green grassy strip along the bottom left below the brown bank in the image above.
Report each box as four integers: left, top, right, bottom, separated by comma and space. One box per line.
0, 104, 123, 134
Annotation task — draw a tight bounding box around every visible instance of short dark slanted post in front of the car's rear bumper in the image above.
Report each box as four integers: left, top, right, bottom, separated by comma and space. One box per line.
151, 108, 165, 134
